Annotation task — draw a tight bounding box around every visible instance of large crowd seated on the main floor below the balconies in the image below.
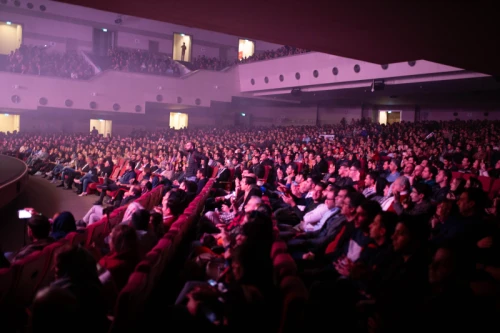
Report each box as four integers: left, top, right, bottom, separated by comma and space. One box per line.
2, 120, 500, 332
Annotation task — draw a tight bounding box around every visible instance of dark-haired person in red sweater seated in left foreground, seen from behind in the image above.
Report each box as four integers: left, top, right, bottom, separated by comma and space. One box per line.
99, 224, 139, 291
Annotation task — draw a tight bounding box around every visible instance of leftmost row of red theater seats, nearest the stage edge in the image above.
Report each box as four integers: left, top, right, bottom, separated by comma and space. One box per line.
0, 186, 163, 308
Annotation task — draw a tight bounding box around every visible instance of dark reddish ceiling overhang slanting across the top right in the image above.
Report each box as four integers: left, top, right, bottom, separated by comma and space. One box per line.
59, 0, 500, 75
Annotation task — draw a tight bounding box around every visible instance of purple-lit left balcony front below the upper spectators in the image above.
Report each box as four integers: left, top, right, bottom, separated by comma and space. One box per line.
0, 68, 239, 114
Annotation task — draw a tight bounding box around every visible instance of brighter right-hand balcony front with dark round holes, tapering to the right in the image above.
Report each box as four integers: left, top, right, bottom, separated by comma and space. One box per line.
238, 52, 486, 96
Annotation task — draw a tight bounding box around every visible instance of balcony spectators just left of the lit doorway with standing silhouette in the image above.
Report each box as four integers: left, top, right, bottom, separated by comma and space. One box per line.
108, 48, 180, 76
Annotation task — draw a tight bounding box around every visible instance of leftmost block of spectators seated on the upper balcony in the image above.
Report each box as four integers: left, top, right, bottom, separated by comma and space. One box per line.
5, 45, 94, 80
